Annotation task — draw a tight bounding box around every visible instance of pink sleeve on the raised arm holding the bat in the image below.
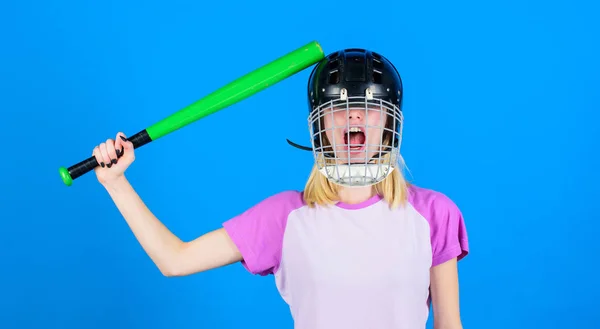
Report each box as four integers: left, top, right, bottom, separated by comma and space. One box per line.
223, 191, 303, 275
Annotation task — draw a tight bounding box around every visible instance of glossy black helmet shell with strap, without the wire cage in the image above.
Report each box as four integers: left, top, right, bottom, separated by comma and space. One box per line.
288, 48, 403, 151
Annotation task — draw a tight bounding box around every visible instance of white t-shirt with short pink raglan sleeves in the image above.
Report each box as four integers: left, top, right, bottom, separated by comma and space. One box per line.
223, 185, 469, 329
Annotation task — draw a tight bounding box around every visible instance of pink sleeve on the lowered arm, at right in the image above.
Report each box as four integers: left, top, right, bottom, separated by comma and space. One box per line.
411, 187, 469, 267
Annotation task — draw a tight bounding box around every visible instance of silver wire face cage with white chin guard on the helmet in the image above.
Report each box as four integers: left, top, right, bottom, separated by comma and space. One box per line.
308, 89, 403, 187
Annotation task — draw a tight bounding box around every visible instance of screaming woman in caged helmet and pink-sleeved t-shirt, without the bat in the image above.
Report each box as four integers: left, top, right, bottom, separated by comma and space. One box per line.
93, 49, 468, 329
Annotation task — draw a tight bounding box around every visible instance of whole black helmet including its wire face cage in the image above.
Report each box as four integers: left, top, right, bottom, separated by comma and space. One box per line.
288, 48, 403, 186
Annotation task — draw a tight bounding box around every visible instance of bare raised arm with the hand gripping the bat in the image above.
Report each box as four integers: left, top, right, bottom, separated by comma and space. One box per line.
93, 133, 242, 276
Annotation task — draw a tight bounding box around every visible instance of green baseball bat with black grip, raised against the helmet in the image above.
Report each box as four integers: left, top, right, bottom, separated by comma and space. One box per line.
58, 41, 325, 186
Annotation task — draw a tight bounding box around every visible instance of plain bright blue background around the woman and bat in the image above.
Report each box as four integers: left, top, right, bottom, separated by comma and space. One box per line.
0, 0, 600, 329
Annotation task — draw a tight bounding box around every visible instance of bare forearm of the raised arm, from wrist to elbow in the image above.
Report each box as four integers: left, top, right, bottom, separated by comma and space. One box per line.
104, 176, 183, 276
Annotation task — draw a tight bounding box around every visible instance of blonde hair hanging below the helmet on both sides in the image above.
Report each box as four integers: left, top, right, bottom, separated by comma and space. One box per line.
304, 154, 408, 208
